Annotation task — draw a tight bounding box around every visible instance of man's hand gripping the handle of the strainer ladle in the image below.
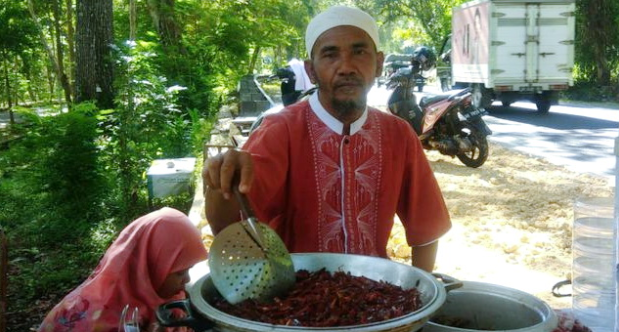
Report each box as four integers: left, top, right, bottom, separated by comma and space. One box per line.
202, 149, 254, 199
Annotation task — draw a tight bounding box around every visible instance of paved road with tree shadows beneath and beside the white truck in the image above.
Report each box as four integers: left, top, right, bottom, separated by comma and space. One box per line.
368, 82, 619, 181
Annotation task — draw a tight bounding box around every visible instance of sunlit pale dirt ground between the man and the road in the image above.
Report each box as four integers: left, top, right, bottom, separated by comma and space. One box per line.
390, 144, 614, 308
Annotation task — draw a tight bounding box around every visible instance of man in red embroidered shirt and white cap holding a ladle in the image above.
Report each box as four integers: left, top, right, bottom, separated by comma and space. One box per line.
203, 6, 451, 271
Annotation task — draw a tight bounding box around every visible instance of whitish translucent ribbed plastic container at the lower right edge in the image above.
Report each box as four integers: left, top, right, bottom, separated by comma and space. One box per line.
572, 197, 616, 332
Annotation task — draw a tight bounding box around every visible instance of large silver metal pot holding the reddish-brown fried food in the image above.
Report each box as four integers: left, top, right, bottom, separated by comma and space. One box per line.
157, 253, 458, 332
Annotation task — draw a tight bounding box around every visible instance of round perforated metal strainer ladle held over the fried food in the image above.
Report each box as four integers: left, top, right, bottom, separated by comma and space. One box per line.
209, 186, 295, 304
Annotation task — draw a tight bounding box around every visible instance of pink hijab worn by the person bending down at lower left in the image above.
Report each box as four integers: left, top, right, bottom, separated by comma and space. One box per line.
39, 208, 207, 332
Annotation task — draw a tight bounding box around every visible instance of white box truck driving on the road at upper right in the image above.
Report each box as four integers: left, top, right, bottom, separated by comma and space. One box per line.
438, 0, 575, 113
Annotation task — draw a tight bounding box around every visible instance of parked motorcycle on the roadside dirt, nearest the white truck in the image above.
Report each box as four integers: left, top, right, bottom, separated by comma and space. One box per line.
387, 56, 492, 168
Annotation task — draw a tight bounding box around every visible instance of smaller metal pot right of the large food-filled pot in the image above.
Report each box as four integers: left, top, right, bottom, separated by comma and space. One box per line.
423, 281, 558, 332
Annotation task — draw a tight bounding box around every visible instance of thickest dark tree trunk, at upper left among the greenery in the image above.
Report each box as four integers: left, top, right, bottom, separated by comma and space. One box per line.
75, 0, 114, 108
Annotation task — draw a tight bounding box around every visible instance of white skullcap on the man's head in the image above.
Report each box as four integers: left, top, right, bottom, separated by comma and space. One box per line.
305, 6, 378, 58
